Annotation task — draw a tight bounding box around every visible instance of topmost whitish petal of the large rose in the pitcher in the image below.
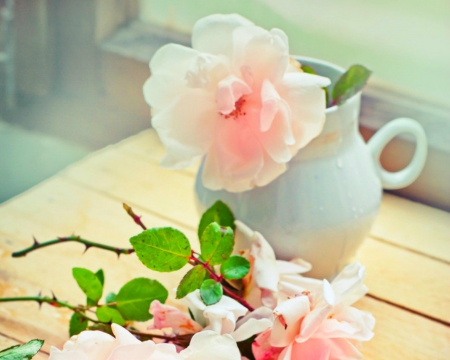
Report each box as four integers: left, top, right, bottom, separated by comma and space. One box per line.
192, 14, 253, 57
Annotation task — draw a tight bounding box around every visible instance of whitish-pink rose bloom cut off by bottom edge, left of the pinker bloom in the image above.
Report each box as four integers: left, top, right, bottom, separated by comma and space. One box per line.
49, 324, 241, 360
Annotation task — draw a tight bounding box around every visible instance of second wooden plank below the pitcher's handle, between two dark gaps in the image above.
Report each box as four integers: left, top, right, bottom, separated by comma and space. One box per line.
358, 237, 450, 323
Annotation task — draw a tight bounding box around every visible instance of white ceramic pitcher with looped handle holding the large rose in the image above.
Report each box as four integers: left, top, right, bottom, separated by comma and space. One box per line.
196, 58, 427, 279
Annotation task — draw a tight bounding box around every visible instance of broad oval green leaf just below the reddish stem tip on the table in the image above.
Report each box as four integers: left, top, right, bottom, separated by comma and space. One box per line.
130, 227, 191, 272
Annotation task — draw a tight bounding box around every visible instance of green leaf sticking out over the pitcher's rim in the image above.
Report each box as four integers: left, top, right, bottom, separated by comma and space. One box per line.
333, 65, 372, 105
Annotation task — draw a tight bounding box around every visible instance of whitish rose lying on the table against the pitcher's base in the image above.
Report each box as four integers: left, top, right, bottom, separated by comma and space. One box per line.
235, 220, 312, 309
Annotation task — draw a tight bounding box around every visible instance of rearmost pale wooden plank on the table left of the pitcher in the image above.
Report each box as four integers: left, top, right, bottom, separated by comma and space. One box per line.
62, 147, 200, 229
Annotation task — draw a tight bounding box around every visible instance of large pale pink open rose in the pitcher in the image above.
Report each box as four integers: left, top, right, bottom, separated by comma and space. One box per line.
144, 14, 330, 192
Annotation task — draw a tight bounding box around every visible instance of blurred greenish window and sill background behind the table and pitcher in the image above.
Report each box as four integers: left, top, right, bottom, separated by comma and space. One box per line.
0, 0, 450, 210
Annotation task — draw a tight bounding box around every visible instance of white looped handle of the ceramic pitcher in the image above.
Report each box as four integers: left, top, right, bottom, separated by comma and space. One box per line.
367, 118, 428, 190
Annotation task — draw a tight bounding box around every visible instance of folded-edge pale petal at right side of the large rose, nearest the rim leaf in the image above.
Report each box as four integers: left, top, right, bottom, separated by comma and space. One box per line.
277, 72, 330, 155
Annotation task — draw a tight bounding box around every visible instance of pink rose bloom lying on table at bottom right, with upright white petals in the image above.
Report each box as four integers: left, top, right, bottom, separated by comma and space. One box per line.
253, 263, 375, 360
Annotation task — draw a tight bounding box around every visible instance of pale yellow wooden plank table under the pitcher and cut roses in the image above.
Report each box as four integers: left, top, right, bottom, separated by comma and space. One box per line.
0, 130, 450, 360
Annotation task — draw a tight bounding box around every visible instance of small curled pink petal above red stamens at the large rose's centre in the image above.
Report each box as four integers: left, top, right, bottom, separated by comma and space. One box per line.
216, 75, 252, 115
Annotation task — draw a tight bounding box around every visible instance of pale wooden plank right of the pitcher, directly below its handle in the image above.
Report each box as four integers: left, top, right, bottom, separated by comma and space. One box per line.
370, 194, 450, 262
